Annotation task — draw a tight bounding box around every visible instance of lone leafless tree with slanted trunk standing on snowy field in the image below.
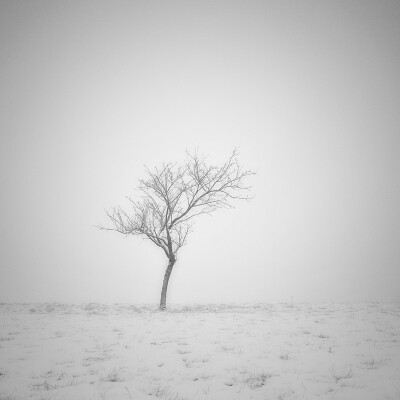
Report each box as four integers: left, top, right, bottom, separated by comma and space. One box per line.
100, 150, 254, 310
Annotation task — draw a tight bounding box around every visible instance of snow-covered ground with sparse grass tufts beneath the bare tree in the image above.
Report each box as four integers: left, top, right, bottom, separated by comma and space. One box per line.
0, 303, 400, 400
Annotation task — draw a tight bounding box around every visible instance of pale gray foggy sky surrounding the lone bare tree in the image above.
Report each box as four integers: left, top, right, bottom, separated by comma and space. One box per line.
0, 0, 400, 303
